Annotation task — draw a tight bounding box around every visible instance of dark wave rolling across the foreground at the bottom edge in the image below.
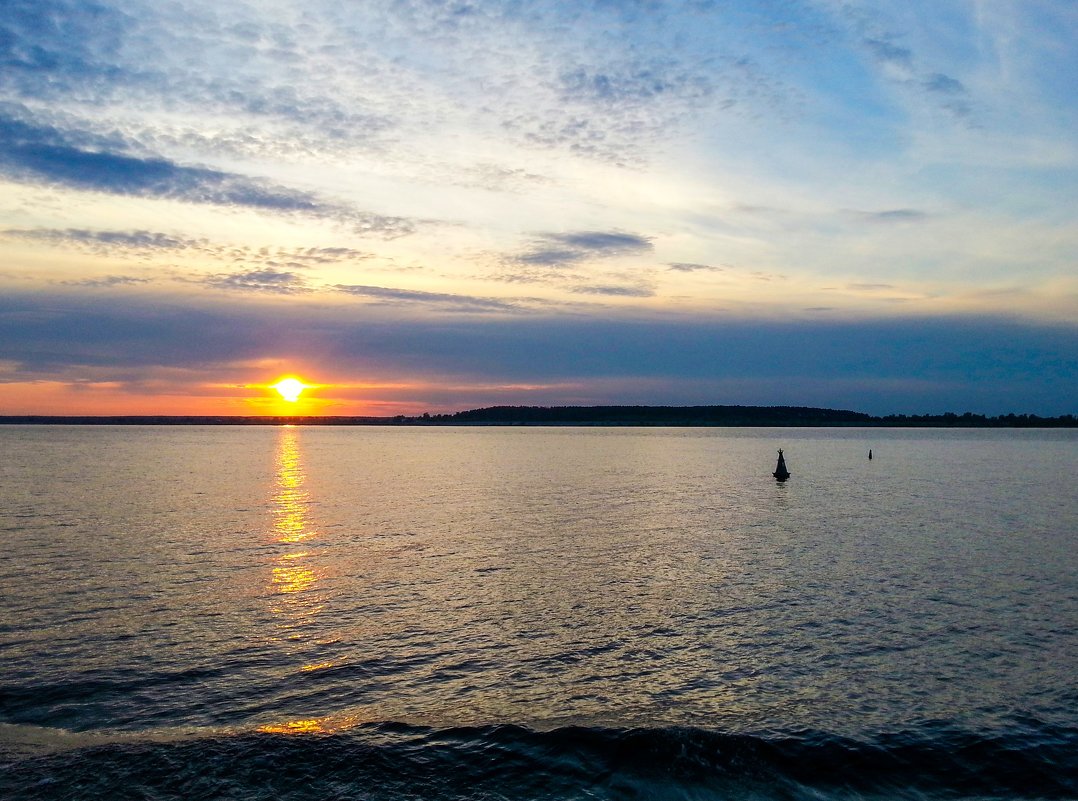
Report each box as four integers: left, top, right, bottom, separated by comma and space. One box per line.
0, 723, 1078, 801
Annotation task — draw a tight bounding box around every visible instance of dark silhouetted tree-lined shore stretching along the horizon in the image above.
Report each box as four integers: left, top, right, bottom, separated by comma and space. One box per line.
0, 406, 1078, 428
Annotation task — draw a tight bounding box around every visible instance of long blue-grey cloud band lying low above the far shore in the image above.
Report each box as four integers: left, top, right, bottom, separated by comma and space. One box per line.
0, 287, 1078, 414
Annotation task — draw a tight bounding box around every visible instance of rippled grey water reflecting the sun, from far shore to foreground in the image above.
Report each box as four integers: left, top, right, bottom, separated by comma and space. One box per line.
0, 427, 1078, 799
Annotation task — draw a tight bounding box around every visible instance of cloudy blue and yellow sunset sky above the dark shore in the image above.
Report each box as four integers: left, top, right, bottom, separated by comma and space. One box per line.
0, 0, 1078, 415
